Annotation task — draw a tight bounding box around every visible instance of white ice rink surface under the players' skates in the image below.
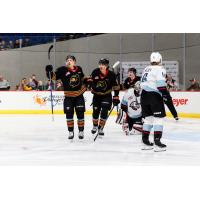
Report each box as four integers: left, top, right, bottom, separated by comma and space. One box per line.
0, 115, 200, 166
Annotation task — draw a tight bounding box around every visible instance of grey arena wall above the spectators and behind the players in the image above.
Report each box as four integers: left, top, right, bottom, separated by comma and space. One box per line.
0, 33, 200, 89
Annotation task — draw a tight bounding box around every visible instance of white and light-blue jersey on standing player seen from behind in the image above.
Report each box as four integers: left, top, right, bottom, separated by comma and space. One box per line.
141, 65, 166, 94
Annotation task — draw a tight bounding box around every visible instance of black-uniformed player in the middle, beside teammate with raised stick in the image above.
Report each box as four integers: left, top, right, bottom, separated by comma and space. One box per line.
91, 58, 120, 136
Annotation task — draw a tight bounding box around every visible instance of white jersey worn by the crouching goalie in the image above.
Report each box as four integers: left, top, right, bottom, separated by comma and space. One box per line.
121, 88, 142, 118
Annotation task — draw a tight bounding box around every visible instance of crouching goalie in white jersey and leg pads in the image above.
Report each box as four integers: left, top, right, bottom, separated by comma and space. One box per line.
116, 81, 142, 135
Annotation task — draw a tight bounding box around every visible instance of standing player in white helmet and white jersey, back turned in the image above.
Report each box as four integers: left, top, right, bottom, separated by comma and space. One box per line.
141, 52, 169, 151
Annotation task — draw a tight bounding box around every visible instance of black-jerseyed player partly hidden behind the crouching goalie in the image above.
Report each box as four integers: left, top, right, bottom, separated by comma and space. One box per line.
123, 67, 140, 89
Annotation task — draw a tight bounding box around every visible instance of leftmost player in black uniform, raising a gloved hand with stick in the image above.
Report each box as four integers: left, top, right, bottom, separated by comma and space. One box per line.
46, 55, 86, 139
